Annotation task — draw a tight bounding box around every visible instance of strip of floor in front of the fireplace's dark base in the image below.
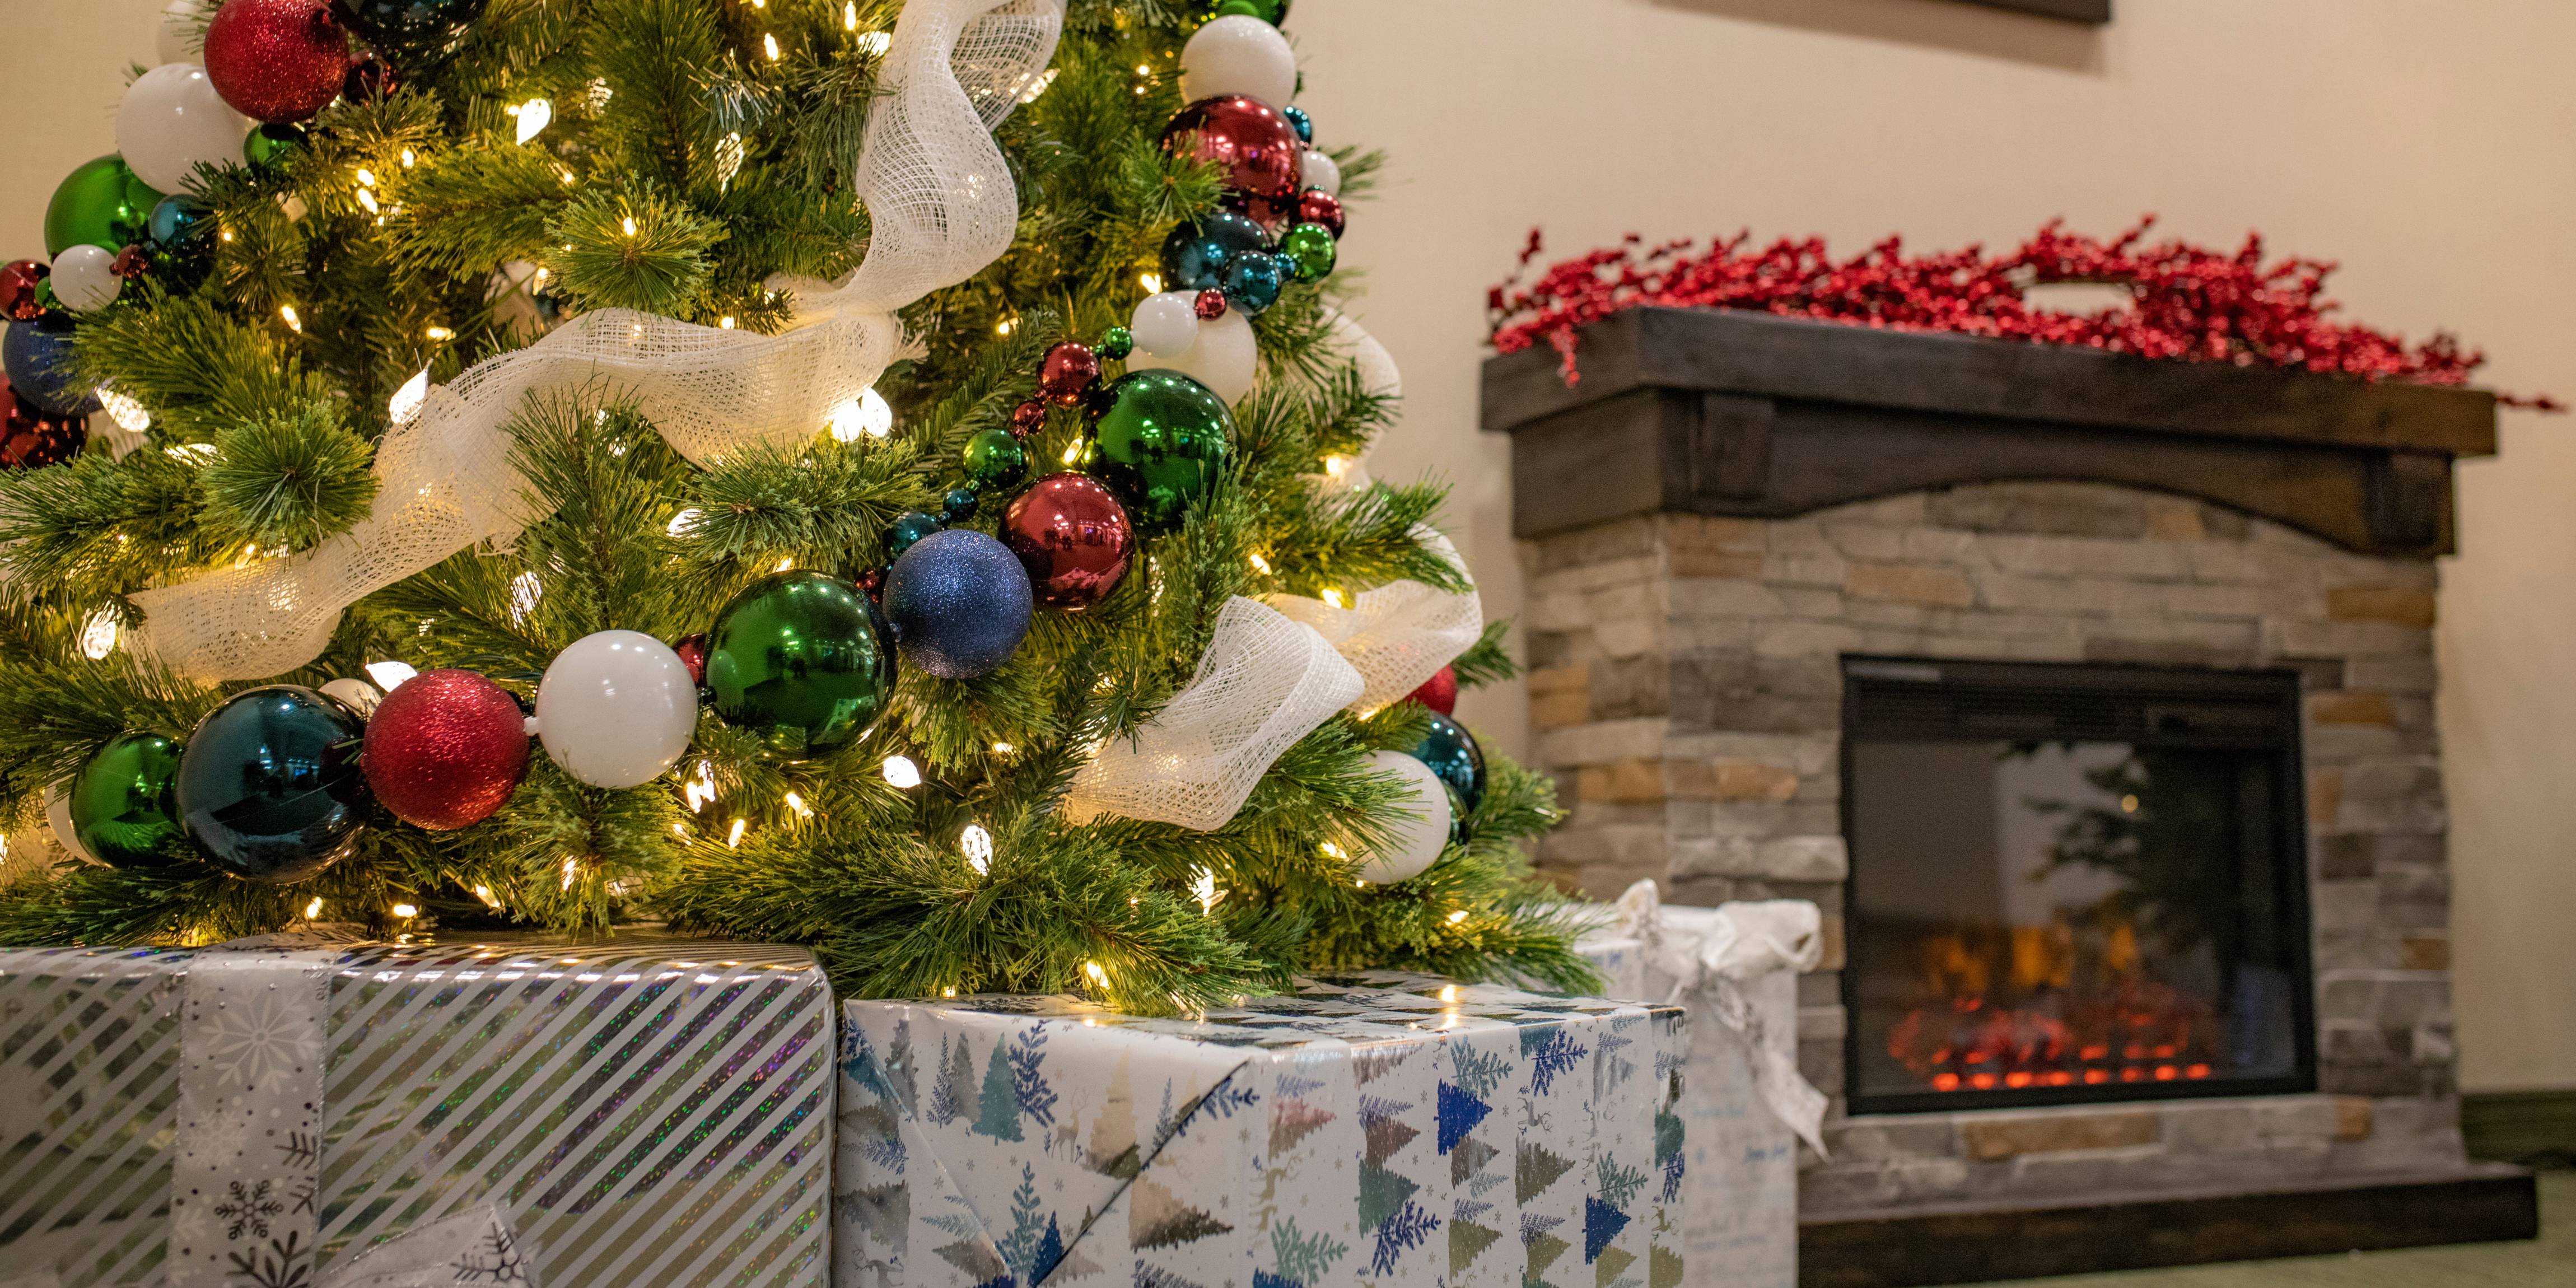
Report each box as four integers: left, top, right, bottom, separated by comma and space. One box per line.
1958, 1172, 2576, 1288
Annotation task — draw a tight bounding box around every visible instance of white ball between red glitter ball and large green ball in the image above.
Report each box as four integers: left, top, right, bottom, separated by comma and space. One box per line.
536, 631, 698, 791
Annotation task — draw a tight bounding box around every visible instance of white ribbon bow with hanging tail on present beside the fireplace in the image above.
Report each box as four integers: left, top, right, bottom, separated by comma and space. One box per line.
1615, 879, 1826, 1156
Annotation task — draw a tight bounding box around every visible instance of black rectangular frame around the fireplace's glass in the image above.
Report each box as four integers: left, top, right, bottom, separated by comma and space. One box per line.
1842, 654, 2318, 1116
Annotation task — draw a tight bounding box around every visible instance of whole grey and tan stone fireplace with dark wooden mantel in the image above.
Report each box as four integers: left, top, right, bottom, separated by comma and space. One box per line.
1486, 309, 2535, 1285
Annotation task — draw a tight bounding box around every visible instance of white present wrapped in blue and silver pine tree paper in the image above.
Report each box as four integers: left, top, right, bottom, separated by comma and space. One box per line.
832, 974, 1690, 1288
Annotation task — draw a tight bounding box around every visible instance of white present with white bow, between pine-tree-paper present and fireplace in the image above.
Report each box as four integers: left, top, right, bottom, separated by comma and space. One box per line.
1579, 881, 1826, 1288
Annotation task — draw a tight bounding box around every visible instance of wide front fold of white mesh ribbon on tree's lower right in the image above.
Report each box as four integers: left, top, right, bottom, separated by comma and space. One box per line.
1064, 598, 1360, 832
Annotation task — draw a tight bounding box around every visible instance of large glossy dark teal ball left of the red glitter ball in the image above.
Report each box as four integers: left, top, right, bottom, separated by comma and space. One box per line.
178, 685, 371, 886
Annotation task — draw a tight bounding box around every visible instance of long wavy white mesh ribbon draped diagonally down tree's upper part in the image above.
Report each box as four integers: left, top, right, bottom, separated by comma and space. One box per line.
132, 0, 1064, 680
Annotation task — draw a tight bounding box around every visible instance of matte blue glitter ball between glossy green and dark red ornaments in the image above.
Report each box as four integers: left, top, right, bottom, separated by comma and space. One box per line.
886, 528, 1035, 680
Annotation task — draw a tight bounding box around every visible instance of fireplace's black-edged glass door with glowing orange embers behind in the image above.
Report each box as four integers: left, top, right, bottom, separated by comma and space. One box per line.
1845, 660, 2313, 1113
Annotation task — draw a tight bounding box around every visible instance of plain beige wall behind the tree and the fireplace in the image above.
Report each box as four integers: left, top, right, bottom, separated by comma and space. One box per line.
15, 0, 2576, 1090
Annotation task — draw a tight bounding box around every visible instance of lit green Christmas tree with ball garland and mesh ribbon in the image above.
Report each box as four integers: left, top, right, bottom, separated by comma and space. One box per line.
0, 0, 1589, 1010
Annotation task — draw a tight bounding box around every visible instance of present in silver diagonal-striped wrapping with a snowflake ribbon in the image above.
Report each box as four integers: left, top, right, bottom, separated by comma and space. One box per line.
0, 940, 832, 1288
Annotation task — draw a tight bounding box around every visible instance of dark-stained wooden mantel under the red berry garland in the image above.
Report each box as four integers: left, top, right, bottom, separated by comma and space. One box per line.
1484, 309, 2496, 557
